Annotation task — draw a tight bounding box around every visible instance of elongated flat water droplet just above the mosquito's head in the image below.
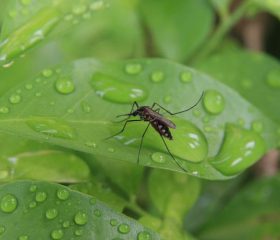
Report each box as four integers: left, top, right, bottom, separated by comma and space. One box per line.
91, 73, 147, 103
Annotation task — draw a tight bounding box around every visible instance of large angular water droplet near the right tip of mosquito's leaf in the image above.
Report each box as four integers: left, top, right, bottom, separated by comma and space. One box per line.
211, 124, 265, 176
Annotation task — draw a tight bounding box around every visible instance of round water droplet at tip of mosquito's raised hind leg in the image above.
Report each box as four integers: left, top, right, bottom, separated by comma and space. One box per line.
203, 90, 225, 114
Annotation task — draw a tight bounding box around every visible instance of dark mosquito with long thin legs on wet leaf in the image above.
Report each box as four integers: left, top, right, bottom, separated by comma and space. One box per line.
106, 92, 204, 172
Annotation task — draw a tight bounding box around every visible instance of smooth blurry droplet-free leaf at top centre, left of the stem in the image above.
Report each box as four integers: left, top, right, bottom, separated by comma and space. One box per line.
140, 0, 214, 61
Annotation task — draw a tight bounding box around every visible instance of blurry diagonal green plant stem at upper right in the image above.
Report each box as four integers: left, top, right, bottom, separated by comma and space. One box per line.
193, 0, 250, 63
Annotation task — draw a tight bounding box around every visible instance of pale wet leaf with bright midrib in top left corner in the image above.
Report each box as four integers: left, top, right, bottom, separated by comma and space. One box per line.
0, 0, 107, 67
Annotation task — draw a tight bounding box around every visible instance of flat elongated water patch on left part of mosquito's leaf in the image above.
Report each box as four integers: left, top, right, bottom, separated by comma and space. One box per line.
26, 117, 76, 139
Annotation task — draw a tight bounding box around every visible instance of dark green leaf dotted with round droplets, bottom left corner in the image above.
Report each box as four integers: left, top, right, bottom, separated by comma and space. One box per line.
0, 181, 160, 240
